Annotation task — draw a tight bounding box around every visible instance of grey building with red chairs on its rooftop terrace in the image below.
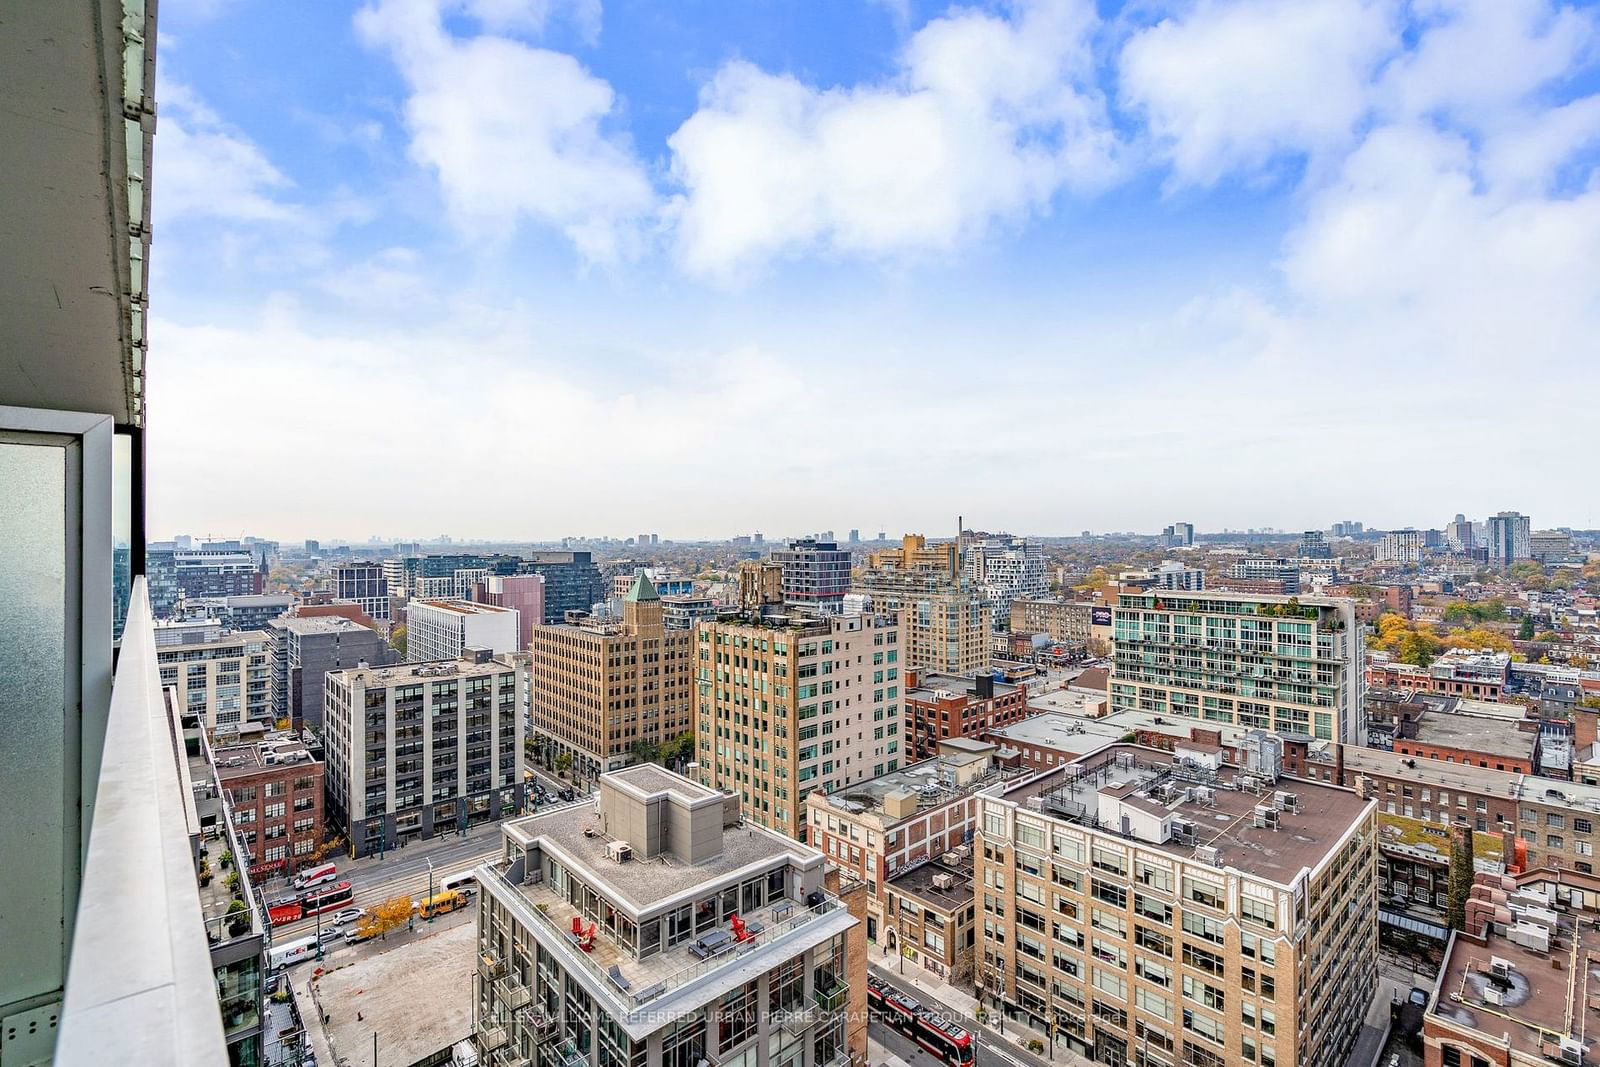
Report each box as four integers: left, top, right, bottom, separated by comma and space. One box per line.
474, 765, 867, 1067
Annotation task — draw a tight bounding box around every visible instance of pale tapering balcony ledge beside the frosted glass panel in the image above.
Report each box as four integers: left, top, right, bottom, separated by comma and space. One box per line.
54, 577, 227, 1067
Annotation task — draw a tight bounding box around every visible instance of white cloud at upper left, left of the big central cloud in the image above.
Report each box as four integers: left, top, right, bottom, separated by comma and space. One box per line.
357, 0, 654, 262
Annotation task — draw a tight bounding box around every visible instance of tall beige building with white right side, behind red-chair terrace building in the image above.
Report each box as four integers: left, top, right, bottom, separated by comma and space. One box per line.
691, 611, 902, 841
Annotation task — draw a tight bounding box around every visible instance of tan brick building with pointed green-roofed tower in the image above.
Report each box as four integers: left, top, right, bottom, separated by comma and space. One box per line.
530, 574, 694, 777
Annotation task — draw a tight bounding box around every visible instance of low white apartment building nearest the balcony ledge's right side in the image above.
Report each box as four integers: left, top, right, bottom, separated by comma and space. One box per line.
155, 630, 272, 729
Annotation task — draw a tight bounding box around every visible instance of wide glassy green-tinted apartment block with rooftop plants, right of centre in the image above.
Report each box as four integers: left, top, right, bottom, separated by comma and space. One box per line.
1110, 590, 1366, 744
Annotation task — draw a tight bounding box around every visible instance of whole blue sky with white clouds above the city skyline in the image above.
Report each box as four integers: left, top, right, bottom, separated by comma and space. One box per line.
150, 0, 1600, 537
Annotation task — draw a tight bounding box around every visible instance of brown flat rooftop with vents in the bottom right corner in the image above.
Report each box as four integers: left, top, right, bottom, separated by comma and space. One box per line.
1429, 915, 1600, 1059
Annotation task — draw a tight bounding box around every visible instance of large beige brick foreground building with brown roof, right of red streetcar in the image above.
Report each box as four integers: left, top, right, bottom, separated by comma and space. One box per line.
974, 745, 1378, 1067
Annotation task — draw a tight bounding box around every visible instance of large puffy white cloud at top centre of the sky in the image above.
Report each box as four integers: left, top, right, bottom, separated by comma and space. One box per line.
669, 0, 1118, 277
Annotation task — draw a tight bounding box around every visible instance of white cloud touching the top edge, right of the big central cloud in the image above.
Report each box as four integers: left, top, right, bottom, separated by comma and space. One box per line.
1120, 0, 1398, 186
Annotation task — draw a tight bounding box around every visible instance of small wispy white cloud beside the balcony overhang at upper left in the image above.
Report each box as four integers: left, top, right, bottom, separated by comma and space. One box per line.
152, 78, 298, 224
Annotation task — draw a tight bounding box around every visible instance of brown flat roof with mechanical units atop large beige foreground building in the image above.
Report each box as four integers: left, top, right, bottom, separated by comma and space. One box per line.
998, 744, 1371, 886
